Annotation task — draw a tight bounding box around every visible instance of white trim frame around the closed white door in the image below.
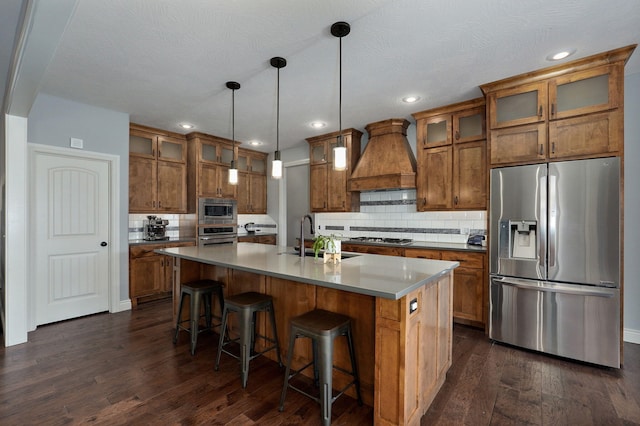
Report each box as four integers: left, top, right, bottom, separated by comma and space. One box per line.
27, 143, 121, 331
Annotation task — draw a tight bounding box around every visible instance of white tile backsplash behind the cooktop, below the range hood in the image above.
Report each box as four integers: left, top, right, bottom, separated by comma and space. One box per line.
315, 189, 487, 243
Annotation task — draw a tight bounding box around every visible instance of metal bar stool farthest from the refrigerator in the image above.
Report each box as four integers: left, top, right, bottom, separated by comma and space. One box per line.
173, 280, 224, 355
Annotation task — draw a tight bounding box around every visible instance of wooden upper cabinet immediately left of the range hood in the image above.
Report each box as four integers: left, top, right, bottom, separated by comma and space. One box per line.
307, 129, 362, 212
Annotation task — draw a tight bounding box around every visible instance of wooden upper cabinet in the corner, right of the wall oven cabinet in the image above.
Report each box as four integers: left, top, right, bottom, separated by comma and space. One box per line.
237, 150, 267, 214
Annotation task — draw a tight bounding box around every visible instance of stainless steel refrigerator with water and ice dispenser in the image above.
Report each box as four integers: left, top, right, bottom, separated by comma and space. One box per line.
489, 157, 621, 368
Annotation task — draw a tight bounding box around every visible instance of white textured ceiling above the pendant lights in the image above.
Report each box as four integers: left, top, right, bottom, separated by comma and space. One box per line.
32, 0, 640, 152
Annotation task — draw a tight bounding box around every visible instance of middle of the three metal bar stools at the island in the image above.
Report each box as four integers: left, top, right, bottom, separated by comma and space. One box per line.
215, 292, 282, 388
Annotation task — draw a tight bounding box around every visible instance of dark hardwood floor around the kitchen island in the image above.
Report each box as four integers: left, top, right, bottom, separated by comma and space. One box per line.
0, 301, 640, 425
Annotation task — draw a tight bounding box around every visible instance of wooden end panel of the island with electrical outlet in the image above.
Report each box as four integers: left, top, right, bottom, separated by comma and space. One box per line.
374, 273, 453, 425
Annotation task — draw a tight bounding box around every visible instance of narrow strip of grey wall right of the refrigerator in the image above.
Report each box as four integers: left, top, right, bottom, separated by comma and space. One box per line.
624, 70, 640, 343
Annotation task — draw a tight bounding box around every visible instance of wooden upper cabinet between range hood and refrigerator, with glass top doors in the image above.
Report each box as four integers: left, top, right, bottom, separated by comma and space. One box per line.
413, 98, 487, 211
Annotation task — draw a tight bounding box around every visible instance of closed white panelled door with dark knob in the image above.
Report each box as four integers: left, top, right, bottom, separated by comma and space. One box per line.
31, 152, 111, 325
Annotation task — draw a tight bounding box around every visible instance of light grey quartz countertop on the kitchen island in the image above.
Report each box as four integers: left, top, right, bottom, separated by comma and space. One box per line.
155, 243, 459, 300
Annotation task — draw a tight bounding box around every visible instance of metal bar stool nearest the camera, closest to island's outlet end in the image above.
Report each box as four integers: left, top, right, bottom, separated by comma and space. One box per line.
279, 309, 362, 425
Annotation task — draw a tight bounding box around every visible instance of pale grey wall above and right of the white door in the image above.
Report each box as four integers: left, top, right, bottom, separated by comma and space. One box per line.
28, 93, 129, 301
